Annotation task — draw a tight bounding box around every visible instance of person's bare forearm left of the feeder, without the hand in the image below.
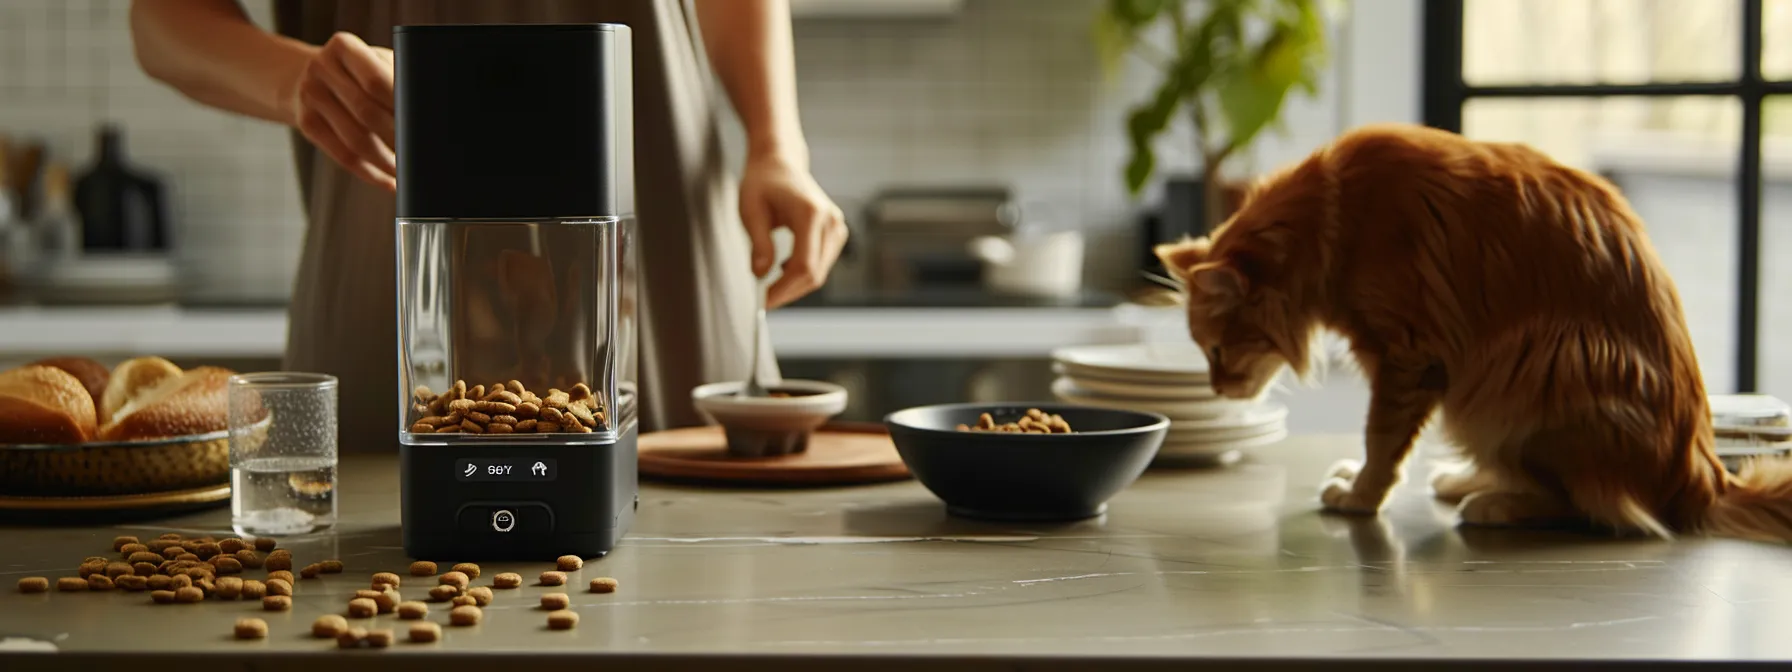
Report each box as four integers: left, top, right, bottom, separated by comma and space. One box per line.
131, 0, 317, 125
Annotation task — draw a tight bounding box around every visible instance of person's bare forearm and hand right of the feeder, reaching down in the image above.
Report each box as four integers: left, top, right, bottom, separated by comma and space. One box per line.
695, 0, 848, 308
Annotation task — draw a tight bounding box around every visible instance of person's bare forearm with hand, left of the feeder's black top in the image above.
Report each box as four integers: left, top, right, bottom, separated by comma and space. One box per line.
131, 0, 398, 190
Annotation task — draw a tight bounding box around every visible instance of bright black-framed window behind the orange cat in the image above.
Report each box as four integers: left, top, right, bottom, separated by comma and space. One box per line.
1423, 0, 1792, 398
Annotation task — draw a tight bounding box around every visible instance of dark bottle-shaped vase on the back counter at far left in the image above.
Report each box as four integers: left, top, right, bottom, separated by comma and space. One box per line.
75, 125, 168, 253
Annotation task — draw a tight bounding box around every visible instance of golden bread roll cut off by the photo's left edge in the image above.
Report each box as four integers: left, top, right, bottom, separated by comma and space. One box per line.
0, 366, 95, 444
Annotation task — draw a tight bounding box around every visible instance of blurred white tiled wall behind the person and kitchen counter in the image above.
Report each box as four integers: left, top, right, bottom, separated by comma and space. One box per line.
0, 0, 1383, 299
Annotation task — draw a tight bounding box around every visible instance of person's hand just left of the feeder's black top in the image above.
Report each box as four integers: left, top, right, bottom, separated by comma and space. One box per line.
281, 32, 398, 192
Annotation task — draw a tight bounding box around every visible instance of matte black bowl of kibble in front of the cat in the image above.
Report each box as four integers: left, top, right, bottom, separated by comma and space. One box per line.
883, 403, 1170, 520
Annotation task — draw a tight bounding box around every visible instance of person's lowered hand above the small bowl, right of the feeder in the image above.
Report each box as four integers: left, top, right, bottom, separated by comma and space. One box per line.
740, 156, 848, 308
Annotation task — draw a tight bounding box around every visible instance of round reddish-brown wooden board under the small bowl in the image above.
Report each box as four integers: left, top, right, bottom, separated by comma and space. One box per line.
640, 423, 909, 486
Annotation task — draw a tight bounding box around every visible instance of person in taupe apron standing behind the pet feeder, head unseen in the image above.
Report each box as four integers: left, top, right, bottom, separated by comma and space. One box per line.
131, 0, 846, 452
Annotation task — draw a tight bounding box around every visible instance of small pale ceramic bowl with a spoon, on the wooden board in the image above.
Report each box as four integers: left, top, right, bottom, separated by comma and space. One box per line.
690, 380, 846, 457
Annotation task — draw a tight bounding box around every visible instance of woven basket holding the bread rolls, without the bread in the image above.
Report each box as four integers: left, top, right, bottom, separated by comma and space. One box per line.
0, 418, 272, 496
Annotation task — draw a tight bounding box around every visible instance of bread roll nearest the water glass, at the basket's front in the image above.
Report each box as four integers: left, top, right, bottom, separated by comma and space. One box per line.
99, 366, 231, 441
